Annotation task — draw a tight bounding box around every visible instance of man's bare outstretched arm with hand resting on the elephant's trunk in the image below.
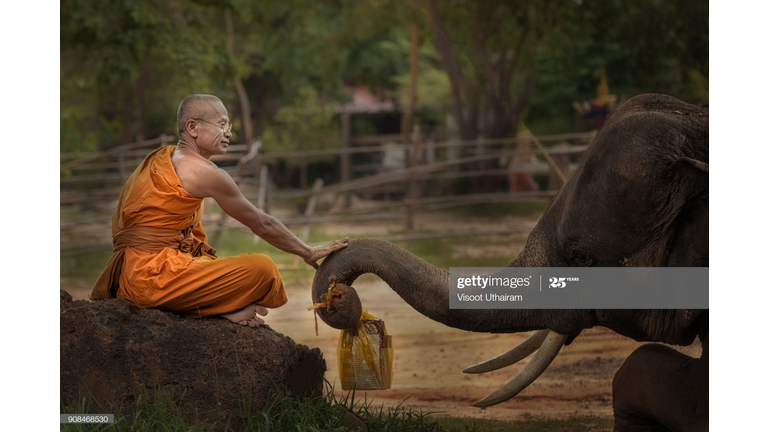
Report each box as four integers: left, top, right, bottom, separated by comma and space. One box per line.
205, 168, 349, 268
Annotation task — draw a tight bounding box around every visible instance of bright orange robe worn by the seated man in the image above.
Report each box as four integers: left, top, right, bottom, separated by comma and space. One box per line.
89, 145, 288, 317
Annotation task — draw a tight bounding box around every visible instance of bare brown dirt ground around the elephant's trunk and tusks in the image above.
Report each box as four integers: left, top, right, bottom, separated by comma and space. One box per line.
61, 208, 701, 421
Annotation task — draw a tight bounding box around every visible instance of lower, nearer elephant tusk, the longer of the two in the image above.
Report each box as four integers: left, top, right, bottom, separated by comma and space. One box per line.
474, 330, 568, 408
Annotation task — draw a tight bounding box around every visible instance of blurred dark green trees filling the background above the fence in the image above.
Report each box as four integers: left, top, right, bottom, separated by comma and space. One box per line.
60, 0, 709, 152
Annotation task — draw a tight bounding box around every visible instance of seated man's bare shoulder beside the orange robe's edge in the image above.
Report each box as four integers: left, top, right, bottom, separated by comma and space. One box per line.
171, 149, 229, 198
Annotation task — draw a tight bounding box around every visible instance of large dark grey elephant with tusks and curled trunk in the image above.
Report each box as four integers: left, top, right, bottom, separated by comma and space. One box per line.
312, 94, 709, 431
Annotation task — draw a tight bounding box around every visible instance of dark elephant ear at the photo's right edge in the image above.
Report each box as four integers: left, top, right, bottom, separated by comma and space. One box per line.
662, 157, 709, 267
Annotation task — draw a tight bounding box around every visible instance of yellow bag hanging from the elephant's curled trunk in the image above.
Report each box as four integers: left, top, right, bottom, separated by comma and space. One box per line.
336, 309, 395, 390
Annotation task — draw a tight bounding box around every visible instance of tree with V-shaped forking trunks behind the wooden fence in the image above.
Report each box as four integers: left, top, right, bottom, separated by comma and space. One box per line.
427, 0, 554, 139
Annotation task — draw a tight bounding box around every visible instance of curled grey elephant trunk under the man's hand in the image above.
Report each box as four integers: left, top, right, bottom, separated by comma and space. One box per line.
312, 239, 564, 333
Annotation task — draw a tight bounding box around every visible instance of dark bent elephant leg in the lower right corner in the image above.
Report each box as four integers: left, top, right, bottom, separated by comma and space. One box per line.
613, 344, 709, 432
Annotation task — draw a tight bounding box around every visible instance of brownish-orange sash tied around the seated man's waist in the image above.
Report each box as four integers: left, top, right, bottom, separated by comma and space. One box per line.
88, 226, 216, 300
